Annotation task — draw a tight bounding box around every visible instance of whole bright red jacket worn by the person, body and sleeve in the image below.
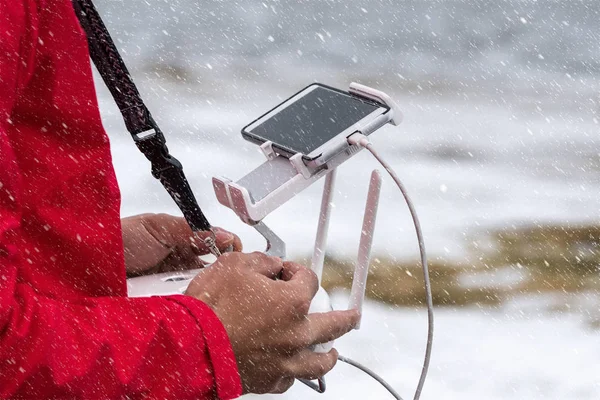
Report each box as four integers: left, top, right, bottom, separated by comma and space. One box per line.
0, 0, 241, 399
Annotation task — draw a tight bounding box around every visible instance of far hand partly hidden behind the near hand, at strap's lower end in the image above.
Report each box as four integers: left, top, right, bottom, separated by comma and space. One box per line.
121, 214, 242, 276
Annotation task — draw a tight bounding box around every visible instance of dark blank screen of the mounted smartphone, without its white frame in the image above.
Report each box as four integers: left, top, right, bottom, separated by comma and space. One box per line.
248, 86, 380, 155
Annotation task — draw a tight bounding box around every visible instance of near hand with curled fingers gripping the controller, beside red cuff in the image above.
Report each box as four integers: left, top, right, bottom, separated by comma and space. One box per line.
186, 253, 359, 393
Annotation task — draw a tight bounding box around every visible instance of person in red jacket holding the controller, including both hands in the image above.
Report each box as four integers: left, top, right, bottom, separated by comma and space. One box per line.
0, 0, 358, 399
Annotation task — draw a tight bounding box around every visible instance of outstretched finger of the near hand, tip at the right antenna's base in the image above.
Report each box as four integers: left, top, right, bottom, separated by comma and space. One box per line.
297, 310, 360, 347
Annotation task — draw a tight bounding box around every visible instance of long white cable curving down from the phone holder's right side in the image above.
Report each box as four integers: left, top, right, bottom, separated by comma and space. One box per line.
348, 133, 433, 400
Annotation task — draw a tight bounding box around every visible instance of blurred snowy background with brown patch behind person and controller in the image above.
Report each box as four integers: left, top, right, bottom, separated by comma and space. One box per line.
95, 0, 600, 400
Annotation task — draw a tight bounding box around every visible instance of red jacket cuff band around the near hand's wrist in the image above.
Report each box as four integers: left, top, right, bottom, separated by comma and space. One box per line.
166, 295, 242, 400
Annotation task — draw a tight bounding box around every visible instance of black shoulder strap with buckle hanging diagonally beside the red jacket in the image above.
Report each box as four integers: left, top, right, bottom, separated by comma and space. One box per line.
73, 0, 211, 231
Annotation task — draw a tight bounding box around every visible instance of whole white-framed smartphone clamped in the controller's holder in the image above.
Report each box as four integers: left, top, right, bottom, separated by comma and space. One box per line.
242, 83, 389, 162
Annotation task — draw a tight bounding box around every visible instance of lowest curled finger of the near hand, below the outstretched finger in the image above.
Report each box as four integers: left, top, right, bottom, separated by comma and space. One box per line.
283, 349, 338, 379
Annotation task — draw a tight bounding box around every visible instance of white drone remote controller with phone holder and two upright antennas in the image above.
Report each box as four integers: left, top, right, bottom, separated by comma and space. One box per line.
127, 83, 402, 392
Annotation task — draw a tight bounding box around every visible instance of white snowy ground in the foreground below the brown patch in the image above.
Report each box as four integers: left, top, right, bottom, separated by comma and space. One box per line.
248, 295, 600, 400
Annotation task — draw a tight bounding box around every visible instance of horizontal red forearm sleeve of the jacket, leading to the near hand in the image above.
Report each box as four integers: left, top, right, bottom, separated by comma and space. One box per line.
0, 288, 241, 399
